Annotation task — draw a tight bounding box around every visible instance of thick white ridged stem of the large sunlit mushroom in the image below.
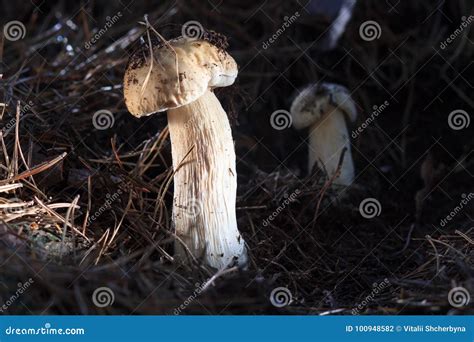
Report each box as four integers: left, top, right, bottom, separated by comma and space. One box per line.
168, 90, 246, 269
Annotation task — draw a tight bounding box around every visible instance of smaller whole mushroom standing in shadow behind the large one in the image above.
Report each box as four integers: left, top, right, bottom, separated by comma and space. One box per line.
290, 83, 357, 186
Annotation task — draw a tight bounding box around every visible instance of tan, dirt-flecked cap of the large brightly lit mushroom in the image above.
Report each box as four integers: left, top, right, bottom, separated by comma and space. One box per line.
123, 37, 238, 117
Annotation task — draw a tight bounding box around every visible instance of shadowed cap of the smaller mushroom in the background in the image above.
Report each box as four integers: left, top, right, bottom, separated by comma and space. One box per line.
290, 83, 357, 129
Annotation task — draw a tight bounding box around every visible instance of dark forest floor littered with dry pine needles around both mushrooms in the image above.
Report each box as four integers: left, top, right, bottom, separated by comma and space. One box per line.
0, 0, 474, 314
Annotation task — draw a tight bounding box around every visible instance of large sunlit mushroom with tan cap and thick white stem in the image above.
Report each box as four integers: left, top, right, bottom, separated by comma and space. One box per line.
124, 37, 247, 269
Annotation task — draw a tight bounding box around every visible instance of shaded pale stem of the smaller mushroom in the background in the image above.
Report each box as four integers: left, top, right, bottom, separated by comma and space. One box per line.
309, 109, 354, 185
